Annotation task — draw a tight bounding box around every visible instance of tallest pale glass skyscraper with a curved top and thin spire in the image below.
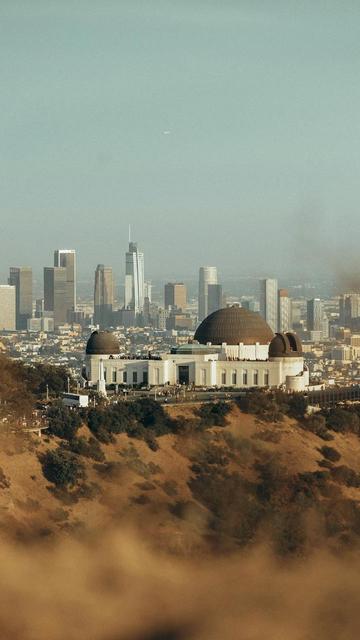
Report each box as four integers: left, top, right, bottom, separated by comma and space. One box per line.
125, 242, 144, 314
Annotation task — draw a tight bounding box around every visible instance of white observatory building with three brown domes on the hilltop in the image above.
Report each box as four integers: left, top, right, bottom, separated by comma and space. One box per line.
84, 307, 309, 391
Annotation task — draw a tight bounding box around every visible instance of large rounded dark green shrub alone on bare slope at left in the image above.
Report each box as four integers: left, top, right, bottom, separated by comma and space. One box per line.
41, 447, 85, 487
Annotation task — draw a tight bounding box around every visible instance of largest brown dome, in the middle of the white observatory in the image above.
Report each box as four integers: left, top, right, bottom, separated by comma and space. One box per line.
194, 307, 274, 345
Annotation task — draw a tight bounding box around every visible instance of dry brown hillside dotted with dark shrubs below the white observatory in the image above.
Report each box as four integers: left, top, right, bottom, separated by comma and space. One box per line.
0, 405, 360, 555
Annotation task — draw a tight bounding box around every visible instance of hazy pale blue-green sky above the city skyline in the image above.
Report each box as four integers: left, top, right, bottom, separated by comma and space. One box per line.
0, 0, 360, 278
